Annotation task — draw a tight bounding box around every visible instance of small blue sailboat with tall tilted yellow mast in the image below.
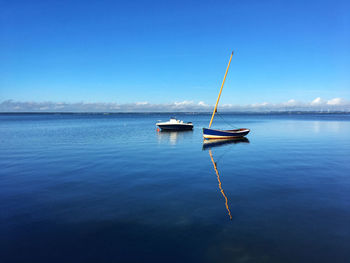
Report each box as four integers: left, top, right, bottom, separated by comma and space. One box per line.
203, 51, 250, 139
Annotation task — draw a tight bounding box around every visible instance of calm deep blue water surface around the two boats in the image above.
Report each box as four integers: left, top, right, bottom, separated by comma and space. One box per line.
0, 114, 350, 262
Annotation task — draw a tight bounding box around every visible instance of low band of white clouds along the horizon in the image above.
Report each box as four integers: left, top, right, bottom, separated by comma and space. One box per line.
0, 98, 350, 113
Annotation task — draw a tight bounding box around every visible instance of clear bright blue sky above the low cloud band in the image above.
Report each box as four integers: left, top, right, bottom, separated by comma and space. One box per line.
0, 0, 350, 108
